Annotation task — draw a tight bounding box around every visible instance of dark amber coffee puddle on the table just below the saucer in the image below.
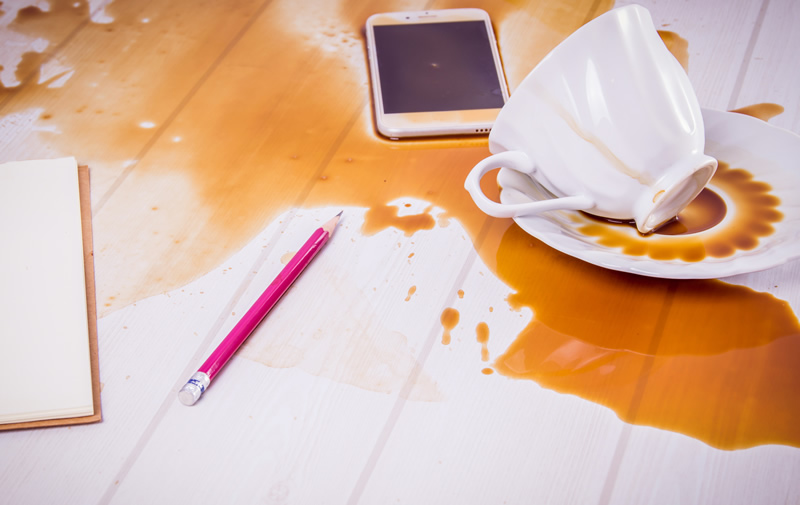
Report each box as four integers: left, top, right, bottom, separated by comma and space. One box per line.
494, 225, 800, 449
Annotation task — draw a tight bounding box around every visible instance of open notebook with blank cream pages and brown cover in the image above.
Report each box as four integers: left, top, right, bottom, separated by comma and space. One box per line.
0, 158, 101, 430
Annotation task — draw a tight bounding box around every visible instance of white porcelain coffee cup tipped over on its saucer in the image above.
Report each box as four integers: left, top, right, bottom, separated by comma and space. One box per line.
464, 5, 717, 233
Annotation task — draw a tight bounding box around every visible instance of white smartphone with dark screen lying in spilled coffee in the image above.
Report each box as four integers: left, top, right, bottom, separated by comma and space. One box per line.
366, 9, 508, 139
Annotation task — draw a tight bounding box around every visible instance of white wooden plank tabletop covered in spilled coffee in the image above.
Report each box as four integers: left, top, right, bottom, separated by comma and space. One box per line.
0, 0, 800, 504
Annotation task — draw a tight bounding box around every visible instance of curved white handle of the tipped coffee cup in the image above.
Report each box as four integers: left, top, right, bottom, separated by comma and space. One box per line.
464, 151, 594, 218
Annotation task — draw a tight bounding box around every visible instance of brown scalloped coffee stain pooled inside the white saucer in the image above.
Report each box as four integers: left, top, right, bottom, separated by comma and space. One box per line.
573, 160, 783, 262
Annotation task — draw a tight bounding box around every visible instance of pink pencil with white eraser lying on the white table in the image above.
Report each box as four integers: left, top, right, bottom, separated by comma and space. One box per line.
178, 212, 342, 405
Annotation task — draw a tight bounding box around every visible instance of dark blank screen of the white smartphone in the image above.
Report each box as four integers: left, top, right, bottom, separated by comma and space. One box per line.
374, 21, 504, 114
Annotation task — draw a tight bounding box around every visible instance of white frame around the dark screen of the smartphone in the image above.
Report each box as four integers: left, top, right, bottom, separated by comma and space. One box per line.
366, 8, 508, 139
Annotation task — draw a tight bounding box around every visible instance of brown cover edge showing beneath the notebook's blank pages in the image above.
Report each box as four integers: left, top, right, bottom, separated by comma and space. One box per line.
0, 165, 102, 431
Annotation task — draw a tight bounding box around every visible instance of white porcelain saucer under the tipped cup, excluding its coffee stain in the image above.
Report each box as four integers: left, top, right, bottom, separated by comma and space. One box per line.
497, 109, 800, 279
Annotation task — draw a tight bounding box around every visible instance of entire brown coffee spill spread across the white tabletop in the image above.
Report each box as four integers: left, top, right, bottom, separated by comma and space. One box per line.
2, 0, 800, 449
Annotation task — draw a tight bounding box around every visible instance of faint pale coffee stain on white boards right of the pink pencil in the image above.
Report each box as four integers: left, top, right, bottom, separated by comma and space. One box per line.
237, 275, 443, 401
